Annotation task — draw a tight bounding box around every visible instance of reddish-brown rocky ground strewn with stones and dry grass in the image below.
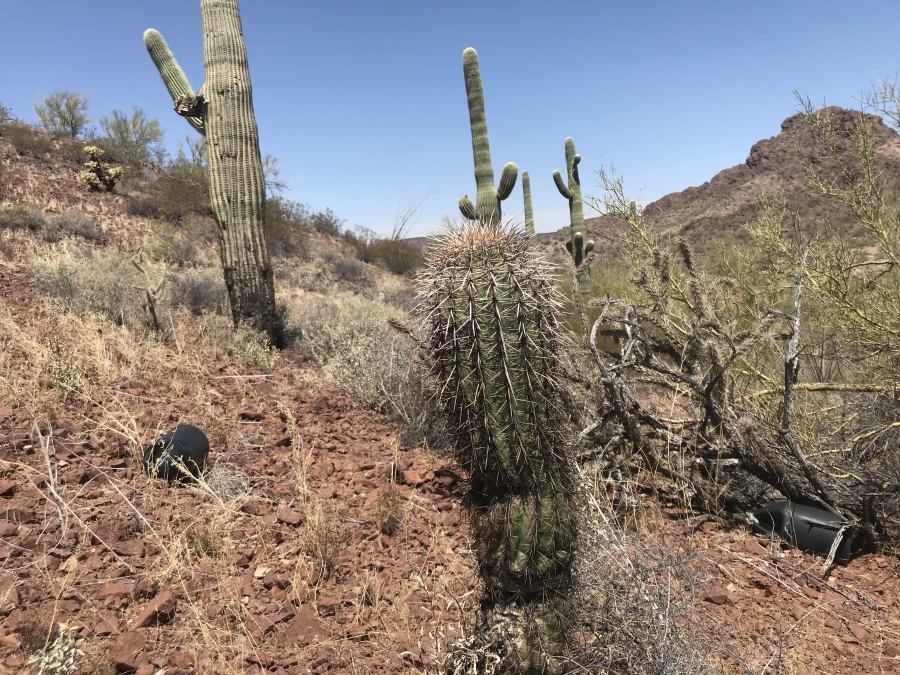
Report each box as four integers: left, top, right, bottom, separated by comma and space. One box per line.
0, 265, 900, 675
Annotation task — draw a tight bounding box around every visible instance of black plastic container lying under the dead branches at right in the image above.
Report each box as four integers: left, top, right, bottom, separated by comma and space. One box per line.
753, 501, 853, 565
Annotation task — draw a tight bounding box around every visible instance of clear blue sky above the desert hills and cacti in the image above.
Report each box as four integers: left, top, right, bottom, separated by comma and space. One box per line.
0, 0, 900, 234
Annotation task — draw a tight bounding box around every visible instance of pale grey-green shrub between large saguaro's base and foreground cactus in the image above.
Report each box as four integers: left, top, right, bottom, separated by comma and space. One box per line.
286, 294, 446, 448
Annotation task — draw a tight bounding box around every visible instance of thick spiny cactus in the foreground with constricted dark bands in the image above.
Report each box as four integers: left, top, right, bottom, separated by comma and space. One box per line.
421, 223, 577, 673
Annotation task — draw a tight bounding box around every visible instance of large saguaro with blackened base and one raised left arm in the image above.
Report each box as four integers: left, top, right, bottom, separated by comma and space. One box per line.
144, 0, 280, 344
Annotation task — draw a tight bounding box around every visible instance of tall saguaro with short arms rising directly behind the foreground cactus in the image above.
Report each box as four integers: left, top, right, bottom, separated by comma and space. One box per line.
459, 47, 519, 223
